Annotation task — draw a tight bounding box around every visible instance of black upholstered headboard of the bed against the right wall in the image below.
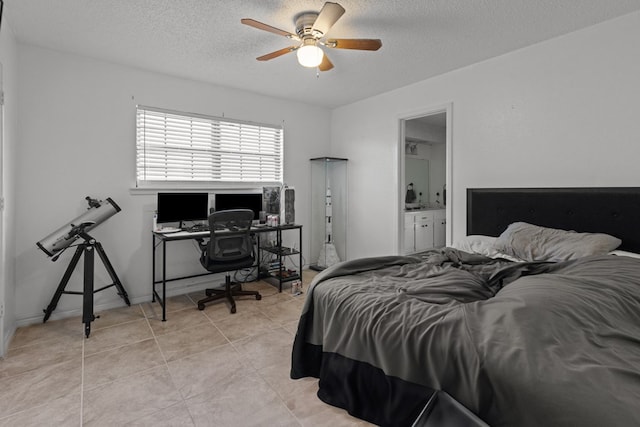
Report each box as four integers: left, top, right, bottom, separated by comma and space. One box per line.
467, 187, 640, 253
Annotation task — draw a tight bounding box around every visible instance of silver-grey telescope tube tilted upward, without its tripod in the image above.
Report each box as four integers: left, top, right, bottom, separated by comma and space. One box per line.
36, 196, 121, 261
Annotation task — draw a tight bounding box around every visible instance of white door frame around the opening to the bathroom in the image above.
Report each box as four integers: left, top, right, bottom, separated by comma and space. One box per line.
396, 102, 454, 254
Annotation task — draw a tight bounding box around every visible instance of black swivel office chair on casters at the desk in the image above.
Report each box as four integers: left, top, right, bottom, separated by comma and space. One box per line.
198, 209, 262, 313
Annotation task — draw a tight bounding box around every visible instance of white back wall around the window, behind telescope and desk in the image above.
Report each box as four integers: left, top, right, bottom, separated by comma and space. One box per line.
15, 44, 330, 325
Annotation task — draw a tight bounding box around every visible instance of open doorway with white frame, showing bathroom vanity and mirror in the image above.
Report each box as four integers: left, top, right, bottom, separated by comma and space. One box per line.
398, 104, 453, 254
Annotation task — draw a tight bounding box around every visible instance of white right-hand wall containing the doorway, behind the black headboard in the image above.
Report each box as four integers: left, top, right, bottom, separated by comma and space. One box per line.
331, 13, 640, 259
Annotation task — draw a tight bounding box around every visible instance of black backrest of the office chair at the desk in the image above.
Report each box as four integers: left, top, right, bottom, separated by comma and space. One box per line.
203, 209, 254, 264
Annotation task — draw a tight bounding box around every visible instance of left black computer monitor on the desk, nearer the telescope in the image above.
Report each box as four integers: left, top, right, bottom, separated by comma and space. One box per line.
157, 193, 209, 223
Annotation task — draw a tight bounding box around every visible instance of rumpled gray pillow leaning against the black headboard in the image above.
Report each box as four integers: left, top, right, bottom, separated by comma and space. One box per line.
493, 222, 622, 261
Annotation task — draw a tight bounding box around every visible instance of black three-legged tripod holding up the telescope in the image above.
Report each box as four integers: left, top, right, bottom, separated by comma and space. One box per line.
42, 232, 131, 338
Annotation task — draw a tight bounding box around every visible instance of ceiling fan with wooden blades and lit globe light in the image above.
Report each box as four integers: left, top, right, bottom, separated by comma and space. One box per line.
240, 2, 382, 71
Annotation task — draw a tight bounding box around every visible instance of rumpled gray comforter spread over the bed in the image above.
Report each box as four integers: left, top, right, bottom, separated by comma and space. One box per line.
291, 249, 640, 426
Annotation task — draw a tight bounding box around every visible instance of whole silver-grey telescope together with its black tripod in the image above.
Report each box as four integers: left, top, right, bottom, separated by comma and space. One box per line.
37, 196, 131, 338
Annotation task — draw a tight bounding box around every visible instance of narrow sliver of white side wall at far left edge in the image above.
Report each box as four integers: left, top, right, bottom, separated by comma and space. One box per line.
0, 19, 18, 356
